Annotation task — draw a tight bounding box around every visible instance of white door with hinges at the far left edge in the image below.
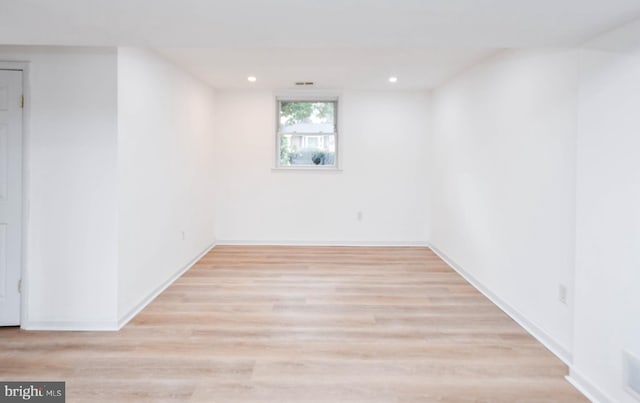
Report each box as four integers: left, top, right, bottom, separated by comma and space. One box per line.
0, 70, 22, 326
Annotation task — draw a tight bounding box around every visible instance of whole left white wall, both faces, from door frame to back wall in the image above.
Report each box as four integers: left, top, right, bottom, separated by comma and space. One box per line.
0, 46, 214, 329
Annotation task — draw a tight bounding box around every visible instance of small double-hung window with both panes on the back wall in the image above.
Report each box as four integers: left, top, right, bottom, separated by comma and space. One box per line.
276, 98, 338, 169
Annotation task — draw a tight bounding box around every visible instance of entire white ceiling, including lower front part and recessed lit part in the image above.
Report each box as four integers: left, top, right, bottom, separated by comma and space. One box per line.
0, 0, 640, 89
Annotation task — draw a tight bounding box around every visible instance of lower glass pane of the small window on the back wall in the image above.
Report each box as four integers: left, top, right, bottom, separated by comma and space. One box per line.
280, 134, 336, 166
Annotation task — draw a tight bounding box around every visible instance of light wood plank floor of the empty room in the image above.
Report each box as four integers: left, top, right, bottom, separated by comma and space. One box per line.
0, 246, 587, 402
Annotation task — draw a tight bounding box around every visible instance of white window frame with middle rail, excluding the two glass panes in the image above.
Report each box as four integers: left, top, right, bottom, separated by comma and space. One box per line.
273, 94, 341, 171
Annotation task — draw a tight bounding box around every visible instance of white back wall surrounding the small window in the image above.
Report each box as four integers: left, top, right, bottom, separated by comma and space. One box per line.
215, 91, 428, 244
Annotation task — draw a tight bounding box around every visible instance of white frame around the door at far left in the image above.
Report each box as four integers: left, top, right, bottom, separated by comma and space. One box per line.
0, 60, 31, 328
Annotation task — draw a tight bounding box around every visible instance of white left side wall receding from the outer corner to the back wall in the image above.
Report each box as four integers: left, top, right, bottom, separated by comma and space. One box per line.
117, 48, 215, 322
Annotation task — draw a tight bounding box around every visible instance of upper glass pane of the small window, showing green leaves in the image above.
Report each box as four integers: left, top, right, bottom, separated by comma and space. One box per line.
279, 101, 335, 133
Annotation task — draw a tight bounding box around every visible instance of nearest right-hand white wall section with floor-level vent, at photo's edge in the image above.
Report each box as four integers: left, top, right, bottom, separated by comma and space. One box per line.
571, 22, 640, 403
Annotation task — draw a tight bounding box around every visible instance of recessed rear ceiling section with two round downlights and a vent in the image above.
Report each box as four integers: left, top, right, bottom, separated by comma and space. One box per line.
156, 48, 495, 90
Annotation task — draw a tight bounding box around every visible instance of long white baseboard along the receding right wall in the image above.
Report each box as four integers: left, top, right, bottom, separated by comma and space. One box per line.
430, 245, 572, 366
